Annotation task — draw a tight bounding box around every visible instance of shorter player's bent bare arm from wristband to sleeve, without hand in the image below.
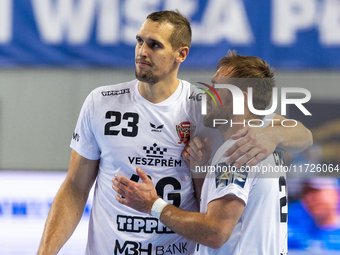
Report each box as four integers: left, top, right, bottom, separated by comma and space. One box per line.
160, 192, 245, 249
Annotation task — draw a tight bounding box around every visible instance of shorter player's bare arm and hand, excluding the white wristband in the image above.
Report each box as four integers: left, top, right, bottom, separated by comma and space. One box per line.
112, 167, 245, 249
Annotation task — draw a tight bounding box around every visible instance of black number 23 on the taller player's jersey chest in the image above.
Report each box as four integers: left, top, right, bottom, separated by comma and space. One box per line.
104, 111, 139, 137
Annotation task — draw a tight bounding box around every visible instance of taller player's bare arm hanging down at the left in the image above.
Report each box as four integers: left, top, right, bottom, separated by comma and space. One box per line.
38, 150, 99, 254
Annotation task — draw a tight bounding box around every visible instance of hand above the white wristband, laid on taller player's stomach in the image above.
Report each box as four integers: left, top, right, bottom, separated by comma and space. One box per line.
112, 167, 159, 214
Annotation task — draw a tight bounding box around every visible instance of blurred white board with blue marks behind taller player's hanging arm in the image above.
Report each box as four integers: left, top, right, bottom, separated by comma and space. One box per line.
0, 171, 93, 255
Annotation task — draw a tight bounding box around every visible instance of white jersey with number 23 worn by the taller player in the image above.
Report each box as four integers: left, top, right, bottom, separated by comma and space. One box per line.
71, 80, 219, 255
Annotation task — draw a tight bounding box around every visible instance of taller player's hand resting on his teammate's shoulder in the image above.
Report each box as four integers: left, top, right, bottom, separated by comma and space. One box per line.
225, 127, 278, 168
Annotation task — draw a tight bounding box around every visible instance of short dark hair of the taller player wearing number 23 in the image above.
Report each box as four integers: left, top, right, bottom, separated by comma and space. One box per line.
146, 10, 191, 50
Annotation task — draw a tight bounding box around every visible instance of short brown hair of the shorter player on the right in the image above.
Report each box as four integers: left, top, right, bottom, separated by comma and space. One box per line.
217, 51, 275, 110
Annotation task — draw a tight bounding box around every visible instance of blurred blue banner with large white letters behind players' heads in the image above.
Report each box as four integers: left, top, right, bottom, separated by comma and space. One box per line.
0, 0, 340, 69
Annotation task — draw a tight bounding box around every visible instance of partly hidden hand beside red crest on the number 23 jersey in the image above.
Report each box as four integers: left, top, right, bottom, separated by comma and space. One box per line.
182, 136, 212, 169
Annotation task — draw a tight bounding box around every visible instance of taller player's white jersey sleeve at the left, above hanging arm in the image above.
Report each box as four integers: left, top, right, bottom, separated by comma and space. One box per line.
70, 93, 100, 160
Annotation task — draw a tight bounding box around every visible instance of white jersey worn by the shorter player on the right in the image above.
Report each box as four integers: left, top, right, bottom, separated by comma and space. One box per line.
195, 140, 288, 255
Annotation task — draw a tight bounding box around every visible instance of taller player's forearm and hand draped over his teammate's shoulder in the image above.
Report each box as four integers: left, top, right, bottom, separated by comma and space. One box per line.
226, 114, 313, 168
